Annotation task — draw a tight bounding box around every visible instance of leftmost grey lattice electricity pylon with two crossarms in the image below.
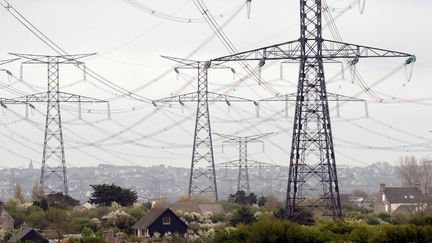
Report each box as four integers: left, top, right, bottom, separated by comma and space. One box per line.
7, 53, 107, 195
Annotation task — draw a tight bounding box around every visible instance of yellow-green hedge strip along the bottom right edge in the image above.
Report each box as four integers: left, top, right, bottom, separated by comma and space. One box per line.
213, 217, 432, 243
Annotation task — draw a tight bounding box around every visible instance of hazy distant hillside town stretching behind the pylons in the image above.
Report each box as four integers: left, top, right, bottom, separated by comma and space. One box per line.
0, 162, 401, 202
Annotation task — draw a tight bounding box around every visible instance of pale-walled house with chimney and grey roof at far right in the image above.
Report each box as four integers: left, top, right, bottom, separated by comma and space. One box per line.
374, 184, 427, 214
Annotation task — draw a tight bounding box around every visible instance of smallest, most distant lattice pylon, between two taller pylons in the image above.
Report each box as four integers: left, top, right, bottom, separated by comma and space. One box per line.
215, 133, 272, 193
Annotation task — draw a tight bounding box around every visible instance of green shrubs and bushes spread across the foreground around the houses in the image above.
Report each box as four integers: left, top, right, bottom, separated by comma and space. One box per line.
4, 184, 432, 243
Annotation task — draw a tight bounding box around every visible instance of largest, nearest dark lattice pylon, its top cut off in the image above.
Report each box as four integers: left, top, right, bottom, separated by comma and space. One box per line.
211, 0, 415, 220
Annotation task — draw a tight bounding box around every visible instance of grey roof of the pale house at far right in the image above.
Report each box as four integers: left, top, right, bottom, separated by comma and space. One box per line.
384, 187, 426, 203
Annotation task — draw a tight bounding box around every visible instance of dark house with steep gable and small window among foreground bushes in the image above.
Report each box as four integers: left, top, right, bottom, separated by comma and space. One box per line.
132, 208, 188, 237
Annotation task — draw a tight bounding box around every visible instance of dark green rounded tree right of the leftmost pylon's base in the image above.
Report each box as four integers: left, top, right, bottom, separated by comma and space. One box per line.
89, 183, 138, 206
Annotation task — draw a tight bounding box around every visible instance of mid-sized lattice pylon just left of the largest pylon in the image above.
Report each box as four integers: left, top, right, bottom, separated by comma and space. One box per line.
153, 57, 253, 201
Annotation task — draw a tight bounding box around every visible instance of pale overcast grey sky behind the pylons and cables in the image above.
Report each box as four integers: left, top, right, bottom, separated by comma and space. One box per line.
0, 0, 432, 170
